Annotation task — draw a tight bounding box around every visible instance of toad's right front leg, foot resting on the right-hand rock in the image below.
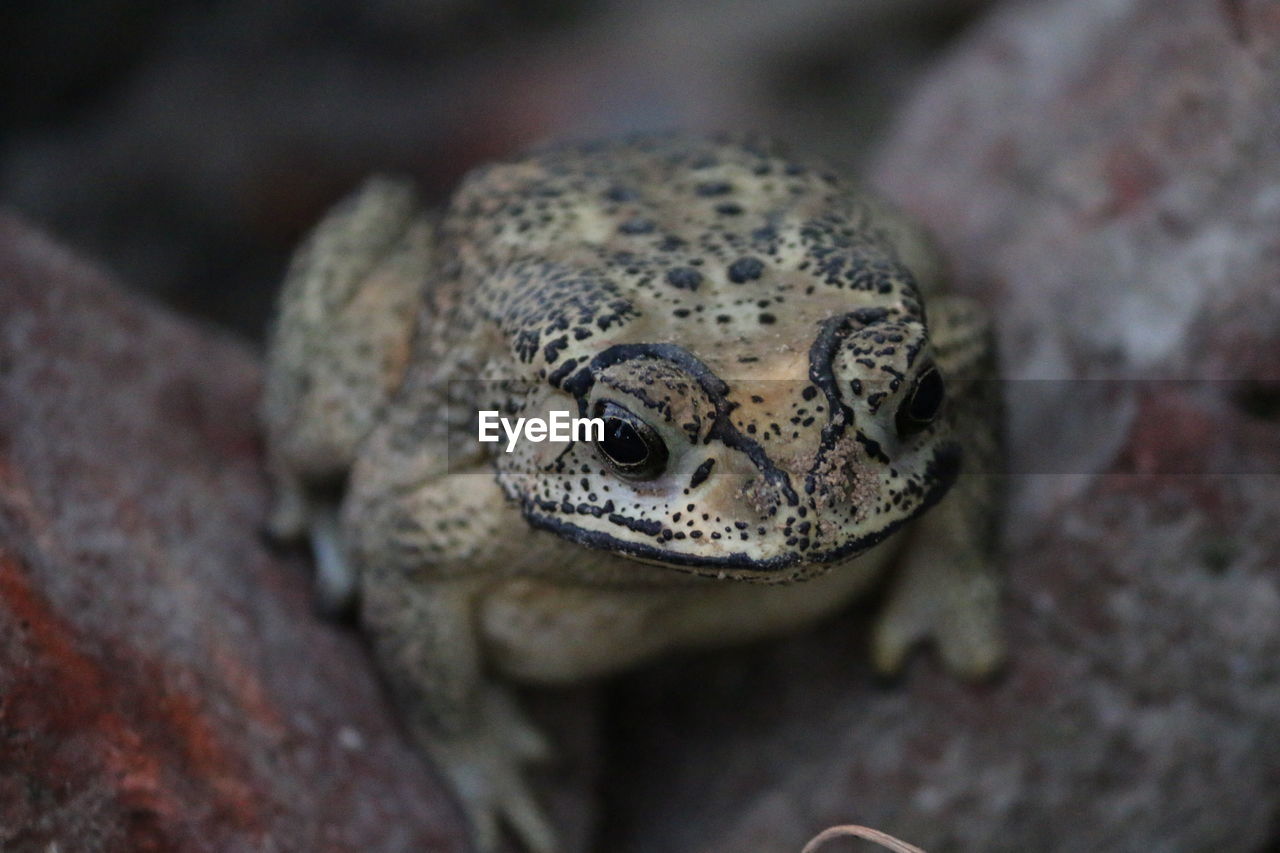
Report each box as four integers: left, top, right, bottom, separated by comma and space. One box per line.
873, 297, 1005, 678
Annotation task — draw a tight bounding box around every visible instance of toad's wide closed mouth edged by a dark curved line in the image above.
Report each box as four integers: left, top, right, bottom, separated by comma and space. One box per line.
524, 443, 963, 583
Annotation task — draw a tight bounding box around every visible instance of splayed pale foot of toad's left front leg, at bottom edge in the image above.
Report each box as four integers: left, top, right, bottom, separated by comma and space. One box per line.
416, 686, 559, 853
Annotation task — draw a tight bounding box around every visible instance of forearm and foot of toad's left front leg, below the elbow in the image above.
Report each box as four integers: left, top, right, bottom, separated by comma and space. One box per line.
362, 570, 558, 853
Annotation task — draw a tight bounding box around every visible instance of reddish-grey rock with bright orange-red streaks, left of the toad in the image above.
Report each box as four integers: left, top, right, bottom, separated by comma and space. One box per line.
0, 215, 589, 853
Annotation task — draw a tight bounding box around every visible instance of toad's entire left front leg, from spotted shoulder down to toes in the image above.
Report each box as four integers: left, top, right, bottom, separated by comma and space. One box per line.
342, 412, 558, 853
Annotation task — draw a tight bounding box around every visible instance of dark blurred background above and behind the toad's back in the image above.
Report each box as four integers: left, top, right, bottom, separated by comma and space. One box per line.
0, 0, 987, 339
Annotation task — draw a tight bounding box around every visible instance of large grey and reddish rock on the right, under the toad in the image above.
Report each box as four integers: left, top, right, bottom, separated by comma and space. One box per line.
607, 0, 1280, 853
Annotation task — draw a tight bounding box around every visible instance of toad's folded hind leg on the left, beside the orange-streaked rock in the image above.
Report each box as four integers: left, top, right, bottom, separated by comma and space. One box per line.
262, 178, 431, 610
